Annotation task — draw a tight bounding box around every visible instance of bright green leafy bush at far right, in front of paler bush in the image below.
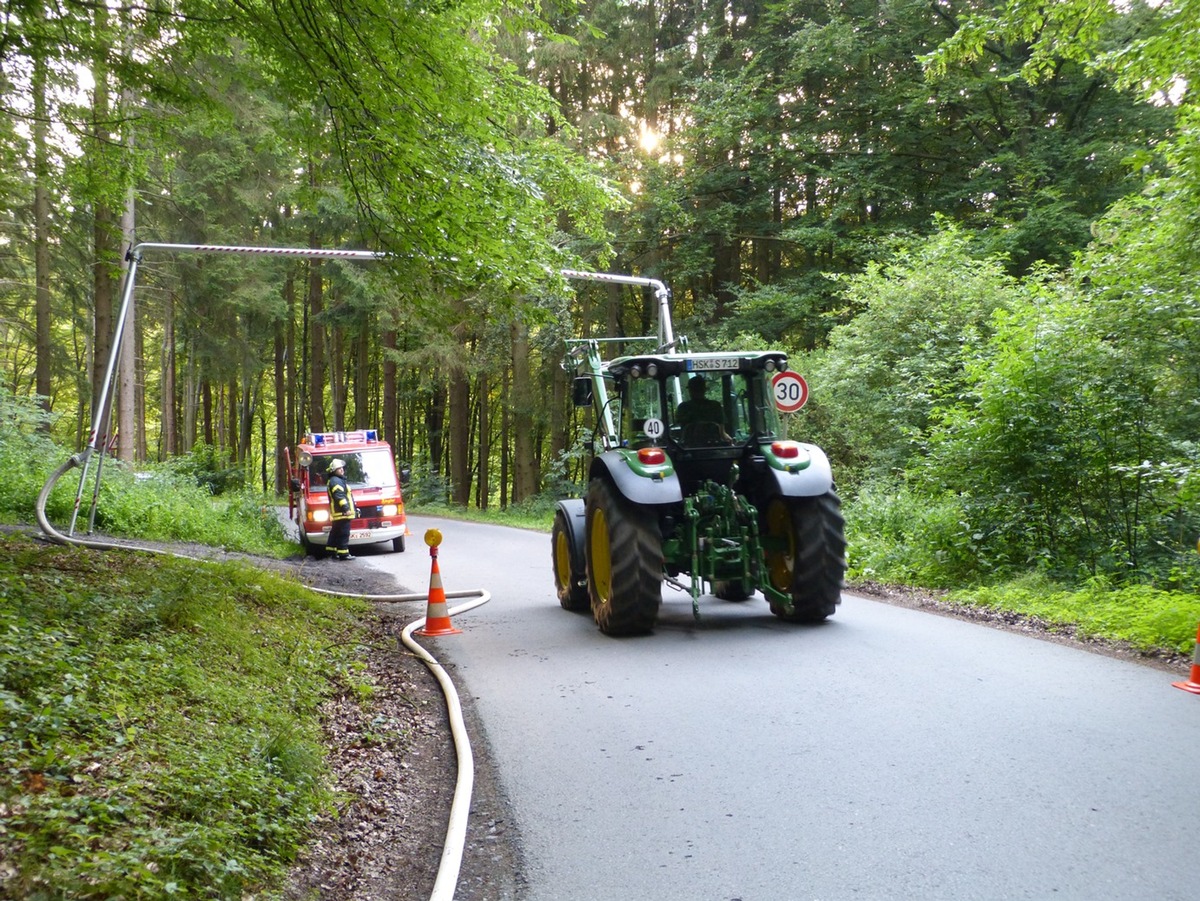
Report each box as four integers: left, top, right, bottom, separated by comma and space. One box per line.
912, 278, 1200, 581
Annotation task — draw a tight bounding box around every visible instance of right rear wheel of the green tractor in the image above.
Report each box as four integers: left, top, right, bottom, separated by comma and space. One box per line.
762, 491, 846, 623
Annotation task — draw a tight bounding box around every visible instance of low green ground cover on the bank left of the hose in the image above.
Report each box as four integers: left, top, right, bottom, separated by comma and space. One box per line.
0, 537, 361, 899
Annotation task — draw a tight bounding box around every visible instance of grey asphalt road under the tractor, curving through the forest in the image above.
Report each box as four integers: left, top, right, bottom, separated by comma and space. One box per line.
362, 518, 1200, 901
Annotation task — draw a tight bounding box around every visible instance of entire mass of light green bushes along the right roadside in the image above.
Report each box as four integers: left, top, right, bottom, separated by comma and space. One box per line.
835, 222, 1200, 590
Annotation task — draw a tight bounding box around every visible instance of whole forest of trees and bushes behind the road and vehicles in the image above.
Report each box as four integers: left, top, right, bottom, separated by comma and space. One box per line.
0, 0, 1200, 593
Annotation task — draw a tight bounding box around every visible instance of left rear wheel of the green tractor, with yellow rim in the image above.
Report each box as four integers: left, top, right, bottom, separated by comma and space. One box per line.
586, 479, 662, 635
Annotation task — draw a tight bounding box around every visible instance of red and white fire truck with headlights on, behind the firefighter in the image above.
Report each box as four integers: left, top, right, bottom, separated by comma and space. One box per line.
286, 428, 409, 555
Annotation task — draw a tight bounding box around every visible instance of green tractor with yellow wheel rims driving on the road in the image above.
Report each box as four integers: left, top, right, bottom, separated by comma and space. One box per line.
552, 271, 846, 636
